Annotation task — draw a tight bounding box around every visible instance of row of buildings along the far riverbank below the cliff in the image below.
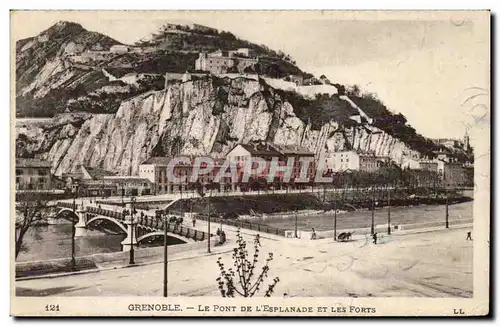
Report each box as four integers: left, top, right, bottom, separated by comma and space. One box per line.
16, 142, 473, 196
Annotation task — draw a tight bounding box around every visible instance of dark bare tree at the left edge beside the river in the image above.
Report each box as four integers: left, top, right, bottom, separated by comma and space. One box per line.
15, 200, 47, 259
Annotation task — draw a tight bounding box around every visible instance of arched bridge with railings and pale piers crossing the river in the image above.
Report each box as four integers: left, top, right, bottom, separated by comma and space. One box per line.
51, 202, 213, 251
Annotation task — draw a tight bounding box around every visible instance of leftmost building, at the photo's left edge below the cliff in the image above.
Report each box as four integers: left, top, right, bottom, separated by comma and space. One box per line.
16, 158, 53, 190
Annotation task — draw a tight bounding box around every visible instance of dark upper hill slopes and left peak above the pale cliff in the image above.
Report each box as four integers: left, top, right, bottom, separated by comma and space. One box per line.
16, 21, 307, 117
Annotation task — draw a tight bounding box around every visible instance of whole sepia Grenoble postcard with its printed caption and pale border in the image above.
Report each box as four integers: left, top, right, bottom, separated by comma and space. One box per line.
10, 10, 491, 317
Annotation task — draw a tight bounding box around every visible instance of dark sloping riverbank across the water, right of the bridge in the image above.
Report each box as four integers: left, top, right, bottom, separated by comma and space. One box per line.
169, 189, 473, 218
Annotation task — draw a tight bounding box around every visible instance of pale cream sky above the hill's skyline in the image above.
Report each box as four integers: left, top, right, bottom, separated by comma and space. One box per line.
11, 11, 490, 138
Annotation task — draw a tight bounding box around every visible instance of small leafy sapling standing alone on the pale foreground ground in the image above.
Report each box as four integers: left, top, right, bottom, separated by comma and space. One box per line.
217, 229, 280, 298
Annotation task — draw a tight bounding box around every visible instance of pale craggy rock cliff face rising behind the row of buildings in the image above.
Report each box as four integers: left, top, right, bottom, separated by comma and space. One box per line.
16, 77, 418, 175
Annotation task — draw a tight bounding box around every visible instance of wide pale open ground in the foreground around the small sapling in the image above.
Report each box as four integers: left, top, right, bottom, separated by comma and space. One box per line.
16, 229, 473, 297
